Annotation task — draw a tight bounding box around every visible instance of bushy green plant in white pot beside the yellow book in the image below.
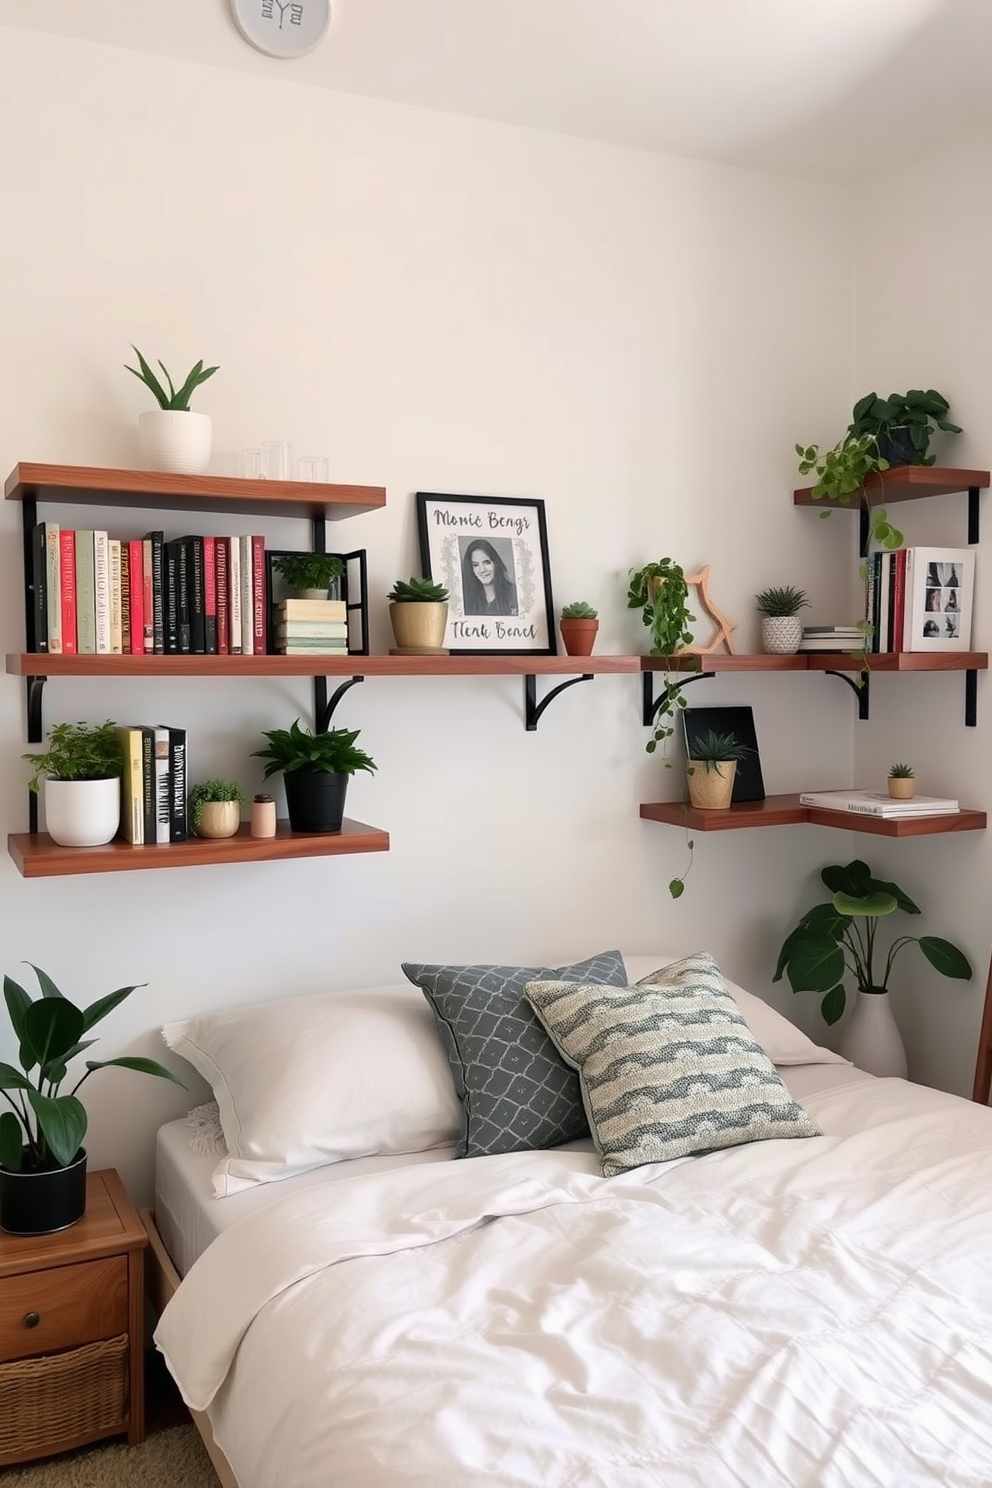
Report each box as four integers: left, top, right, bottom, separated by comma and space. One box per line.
22, 720, 123, 847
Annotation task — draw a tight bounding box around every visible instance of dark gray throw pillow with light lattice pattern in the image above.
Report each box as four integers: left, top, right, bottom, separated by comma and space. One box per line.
403, 951, 626, 1158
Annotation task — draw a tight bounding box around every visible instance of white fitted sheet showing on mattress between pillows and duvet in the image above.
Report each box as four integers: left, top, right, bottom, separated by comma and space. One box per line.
155, 1064, 873, 1277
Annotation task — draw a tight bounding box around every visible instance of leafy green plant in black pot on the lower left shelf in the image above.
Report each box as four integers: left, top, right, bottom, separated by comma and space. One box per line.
254, 719, 376, 832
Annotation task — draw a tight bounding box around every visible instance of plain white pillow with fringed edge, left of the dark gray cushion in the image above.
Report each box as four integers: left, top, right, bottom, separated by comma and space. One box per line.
162, 984, 461, 1198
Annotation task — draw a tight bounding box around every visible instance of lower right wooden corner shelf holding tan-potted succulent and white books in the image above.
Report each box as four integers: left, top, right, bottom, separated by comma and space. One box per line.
641, 795, 986, 836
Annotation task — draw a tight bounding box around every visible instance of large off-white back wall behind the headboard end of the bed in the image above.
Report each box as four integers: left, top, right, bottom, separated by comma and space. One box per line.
0, 30, 862, 1198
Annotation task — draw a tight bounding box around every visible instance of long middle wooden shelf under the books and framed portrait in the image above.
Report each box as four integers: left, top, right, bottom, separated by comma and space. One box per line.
6, 652, 642, 677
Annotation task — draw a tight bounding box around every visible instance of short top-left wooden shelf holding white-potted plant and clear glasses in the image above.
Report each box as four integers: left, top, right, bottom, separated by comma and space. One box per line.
3, 461, 385, 521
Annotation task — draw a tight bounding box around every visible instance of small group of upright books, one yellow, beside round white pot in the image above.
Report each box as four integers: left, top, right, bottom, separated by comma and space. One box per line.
117, 723, 189, 847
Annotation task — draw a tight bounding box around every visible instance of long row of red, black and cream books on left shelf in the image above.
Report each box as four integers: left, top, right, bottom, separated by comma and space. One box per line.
31, 522, 266, 656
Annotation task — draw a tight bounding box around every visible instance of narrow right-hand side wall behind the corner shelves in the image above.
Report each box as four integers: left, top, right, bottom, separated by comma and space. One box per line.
855, 134, 992, 1095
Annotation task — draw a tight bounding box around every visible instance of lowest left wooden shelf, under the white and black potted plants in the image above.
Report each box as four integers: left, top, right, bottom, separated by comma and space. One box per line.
7, 817, 390, 878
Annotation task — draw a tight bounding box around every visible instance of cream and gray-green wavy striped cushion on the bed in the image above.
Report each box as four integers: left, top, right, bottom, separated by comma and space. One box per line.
526, 952, 819, 1177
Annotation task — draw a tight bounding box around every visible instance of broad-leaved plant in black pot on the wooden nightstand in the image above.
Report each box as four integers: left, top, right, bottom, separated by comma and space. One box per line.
0, 963, 184, 1235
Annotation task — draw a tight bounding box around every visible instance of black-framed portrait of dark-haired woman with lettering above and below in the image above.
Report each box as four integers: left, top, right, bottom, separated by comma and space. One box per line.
416, 491, 556, 656
